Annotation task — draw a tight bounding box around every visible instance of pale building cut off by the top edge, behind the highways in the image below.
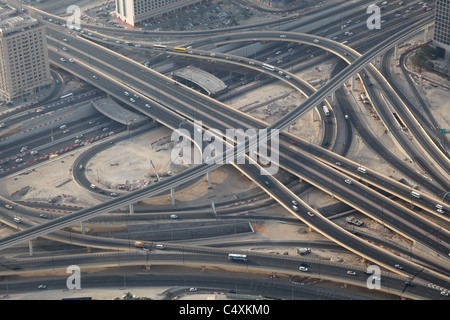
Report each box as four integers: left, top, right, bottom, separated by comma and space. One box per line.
115, 0, 209, 26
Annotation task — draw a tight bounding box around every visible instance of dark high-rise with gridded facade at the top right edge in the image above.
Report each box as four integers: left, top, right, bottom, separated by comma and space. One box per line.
433, 0, 450, 61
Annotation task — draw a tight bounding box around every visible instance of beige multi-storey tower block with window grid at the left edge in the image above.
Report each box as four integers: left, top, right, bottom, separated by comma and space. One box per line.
0, 6, 52, 102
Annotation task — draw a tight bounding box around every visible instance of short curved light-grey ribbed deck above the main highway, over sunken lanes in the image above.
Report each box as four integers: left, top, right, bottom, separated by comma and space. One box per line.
172, 66, 227, 96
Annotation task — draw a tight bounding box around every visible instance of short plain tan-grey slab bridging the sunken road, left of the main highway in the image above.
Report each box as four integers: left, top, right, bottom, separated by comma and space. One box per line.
92, 97, 148, 126
